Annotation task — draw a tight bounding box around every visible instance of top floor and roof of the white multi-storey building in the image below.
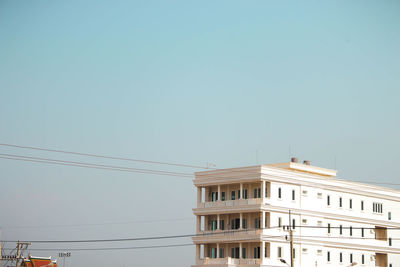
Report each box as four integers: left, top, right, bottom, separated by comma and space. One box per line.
194, 159, 400, 225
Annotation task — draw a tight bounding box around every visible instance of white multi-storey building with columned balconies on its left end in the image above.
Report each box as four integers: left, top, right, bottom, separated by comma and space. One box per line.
193, 158, 400, 267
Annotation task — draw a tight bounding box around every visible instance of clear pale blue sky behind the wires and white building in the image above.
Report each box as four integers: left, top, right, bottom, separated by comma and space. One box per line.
0, 0, 400, 267
